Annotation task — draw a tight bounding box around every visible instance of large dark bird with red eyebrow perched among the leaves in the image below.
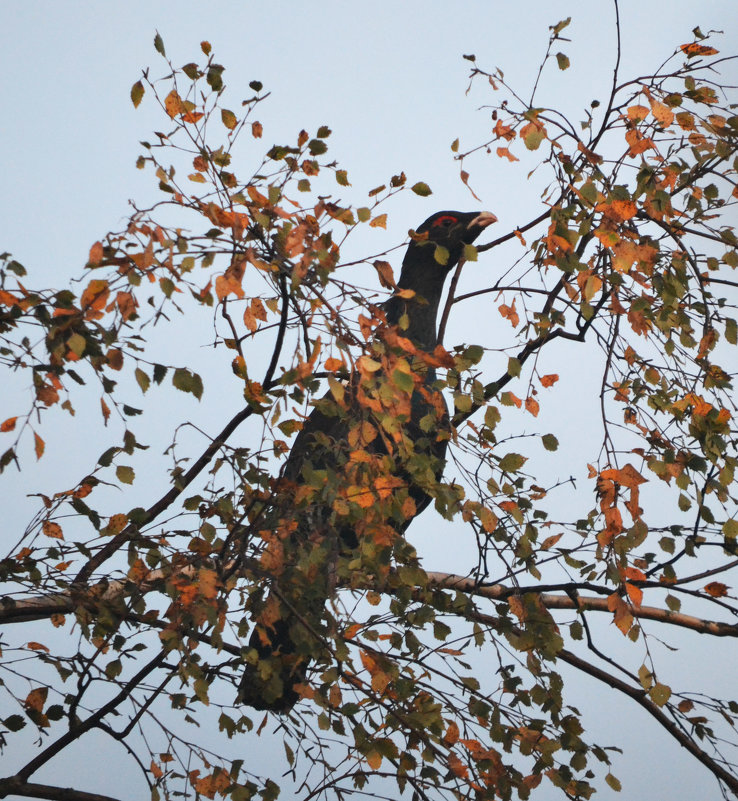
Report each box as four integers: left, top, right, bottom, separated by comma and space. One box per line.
237, 211, 497, 713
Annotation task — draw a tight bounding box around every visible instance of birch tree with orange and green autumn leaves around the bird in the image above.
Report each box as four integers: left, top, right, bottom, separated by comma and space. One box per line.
0, 10, 738, 799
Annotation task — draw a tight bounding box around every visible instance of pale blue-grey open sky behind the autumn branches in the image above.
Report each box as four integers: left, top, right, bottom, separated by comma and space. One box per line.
0, 0, 738, 801
